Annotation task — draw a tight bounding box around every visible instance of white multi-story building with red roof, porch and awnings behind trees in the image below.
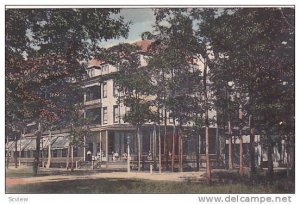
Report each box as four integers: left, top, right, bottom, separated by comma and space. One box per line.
6, 40, 286, 170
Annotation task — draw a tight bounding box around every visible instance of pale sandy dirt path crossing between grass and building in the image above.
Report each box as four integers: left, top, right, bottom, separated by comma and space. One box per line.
6, 172, 204, 187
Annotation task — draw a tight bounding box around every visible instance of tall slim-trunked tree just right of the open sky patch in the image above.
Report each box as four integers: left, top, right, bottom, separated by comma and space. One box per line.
149, 9, 201, 171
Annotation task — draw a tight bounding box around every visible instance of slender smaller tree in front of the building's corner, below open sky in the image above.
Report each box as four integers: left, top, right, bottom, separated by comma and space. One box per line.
114, 44, 155, 171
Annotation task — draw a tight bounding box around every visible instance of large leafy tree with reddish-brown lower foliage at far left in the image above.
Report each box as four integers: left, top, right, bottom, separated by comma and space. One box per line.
5, 9, 128, 174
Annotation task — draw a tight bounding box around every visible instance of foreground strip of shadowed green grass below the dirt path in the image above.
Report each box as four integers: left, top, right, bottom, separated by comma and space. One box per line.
6, 178, 291, 194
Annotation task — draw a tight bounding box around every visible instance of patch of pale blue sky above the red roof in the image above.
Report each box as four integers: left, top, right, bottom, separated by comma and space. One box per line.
100, 8, 155, 47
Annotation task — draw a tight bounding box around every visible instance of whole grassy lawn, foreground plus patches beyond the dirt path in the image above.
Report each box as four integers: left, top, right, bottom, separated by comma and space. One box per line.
6, 167, 295, 194
